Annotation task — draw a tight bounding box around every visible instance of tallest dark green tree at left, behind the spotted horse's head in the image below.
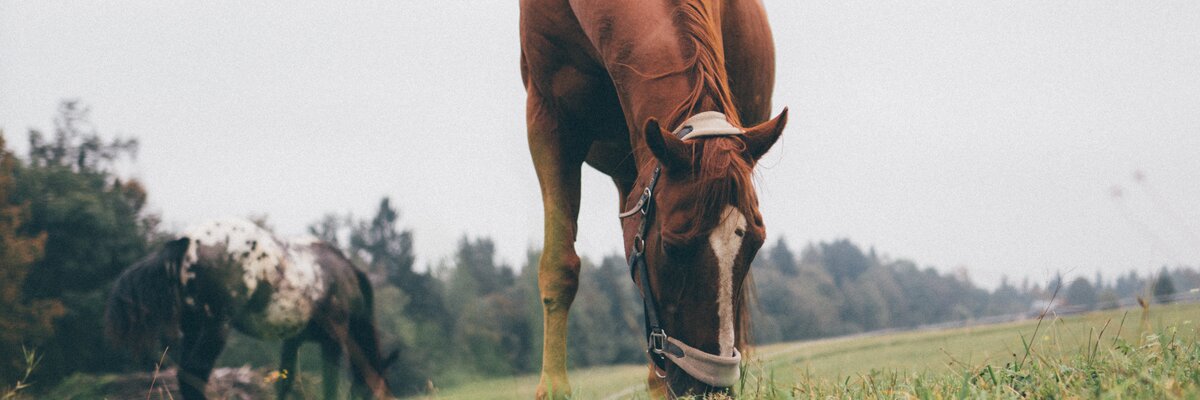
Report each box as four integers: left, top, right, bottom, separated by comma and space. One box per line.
8, 101, 160, 380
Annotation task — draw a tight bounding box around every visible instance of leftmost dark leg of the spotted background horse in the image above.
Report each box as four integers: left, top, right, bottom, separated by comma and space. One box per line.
178, 311, 229, 400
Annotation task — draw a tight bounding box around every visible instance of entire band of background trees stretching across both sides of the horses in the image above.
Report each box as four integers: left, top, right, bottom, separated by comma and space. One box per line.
0, 102, 1200, 393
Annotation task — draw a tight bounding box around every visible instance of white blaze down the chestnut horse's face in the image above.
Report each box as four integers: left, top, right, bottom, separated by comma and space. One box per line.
708, 205, 746, 356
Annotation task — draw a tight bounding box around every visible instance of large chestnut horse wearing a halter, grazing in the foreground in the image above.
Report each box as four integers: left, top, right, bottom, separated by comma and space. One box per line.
521, 0, 786, 398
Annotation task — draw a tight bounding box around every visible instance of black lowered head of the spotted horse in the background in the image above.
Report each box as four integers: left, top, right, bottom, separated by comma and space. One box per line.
104, 238, 188, 352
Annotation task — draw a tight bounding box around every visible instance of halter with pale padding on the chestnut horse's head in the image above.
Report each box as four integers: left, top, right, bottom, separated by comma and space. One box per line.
618, 112, 743, 387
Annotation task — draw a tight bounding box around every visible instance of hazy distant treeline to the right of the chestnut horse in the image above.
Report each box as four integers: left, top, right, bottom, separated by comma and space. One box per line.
751, 239, 1200, 342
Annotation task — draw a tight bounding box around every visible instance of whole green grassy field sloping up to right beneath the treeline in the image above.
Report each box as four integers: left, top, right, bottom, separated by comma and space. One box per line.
415, 304, 1200, 399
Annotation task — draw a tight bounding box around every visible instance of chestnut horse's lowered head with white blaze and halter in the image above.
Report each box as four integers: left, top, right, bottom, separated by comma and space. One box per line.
623, 109, 787, 395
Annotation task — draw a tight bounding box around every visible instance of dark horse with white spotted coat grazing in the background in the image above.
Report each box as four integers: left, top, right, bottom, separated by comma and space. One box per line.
106, 219, 396, 400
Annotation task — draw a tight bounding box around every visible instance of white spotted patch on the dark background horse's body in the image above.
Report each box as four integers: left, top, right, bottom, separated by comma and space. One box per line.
181, 220, 325, 339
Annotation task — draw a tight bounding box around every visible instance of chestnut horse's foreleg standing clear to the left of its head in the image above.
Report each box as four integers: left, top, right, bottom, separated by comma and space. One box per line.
527, 92, 588, 399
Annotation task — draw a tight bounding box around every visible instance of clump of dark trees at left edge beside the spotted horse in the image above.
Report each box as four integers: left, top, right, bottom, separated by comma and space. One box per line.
0, 101, 162, 389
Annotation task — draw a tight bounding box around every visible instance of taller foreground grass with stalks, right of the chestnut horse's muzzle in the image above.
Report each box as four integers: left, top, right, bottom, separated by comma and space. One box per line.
737, 306, 1200, 399
